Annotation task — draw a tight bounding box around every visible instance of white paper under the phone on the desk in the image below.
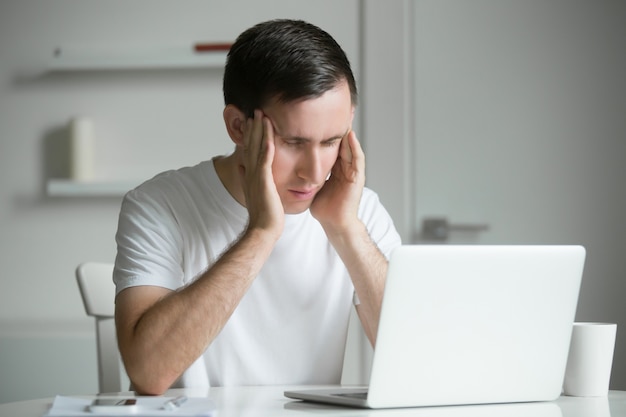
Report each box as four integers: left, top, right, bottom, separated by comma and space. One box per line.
43, 395, 217, 417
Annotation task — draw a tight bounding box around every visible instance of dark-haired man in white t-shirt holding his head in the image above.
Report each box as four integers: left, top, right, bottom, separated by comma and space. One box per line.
114, 20, 400, 394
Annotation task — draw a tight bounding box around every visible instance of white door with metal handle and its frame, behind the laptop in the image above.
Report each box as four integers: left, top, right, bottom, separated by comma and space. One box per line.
362, 0, 626, 389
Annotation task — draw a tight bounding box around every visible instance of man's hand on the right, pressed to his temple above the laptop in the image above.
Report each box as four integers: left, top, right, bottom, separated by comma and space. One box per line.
311, 130, 365, 233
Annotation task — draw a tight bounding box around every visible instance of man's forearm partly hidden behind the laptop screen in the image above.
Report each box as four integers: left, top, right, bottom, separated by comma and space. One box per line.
326, 220, 388, 346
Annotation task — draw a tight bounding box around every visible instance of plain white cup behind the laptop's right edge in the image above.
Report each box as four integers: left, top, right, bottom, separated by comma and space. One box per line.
563, 323, 617, 397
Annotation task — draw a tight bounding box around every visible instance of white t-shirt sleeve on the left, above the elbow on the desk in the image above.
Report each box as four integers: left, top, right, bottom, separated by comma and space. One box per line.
113, 189, 183, 294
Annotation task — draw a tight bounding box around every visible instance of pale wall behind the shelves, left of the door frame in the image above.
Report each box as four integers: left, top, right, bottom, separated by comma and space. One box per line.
0, 0, 359, 402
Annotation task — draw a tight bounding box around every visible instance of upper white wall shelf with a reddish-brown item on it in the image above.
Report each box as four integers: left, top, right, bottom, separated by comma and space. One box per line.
47, 44, 229, 72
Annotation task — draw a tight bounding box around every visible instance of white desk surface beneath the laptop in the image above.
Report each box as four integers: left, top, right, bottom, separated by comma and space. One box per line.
0, 386, 626, 417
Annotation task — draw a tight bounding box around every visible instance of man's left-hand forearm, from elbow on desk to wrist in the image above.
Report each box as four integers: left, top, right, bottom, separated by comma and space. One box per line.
116, 231, 274, 394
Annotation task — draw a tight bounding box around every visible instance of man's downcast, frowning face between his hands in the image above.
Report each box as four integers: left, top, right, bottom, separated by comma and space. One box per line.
262, 82, 354, 214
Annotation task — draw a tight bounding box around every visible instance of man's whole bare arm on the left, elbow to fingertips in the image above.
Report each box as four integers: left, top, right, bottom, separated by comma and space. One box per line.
115, 111, 285, 395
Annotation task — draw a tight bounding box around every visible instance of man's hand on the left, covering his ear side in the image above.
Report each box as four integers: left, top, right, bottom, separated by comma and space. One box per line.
239, 110, 285, 239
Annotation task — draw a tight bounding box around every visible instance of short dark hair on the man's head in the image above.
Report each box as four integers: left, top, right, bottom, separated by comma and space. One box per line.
223, 19, 358, 117
